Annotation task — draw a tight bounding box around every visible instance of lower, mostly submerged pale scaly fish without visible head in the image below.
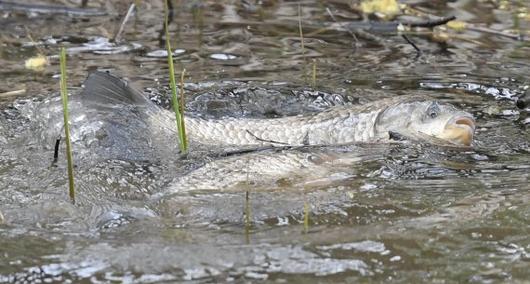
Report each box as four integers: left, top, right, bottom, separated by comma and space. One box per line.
153, 144, 391, 197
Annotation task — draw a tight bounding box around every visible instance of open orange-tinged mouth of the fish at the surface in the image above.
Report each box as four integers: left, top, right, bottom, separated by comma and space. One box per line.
439, 116, 475, 146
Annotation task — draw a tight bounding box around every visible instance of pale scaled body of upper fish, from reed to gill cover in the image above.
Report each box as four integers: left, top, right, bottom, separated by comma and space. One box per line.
174, 107, 384, 145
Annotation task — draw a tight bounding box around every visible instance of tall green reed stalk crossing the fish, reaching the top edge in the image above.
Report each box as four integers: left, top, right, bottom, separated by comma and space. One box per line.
164, 0, 188, 153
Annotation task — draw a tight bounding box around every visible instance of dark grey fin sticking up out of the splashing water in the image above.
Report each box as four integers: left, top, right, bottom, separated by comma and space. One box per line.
81, 71, 150, 106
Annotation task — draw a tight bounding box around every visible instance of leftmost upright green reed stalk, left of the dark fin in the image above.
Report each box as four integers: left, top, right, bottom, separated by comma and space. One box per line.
60, 47, 75, 203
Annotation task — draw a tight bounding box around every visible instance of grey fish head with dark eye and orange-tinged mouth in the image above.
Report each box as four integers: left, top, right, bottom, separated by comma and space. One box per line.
378, 100, 475, 146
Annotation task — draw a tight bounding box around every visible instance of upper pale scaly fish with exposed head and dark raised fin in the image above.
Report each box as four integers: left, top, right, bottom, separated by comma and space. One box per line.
81, 72, 475, 149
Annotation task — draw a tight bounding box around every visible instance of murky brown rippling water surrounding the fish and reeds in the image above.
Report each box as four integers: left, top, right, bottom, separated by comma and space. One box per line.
0, 1, 530, 283
